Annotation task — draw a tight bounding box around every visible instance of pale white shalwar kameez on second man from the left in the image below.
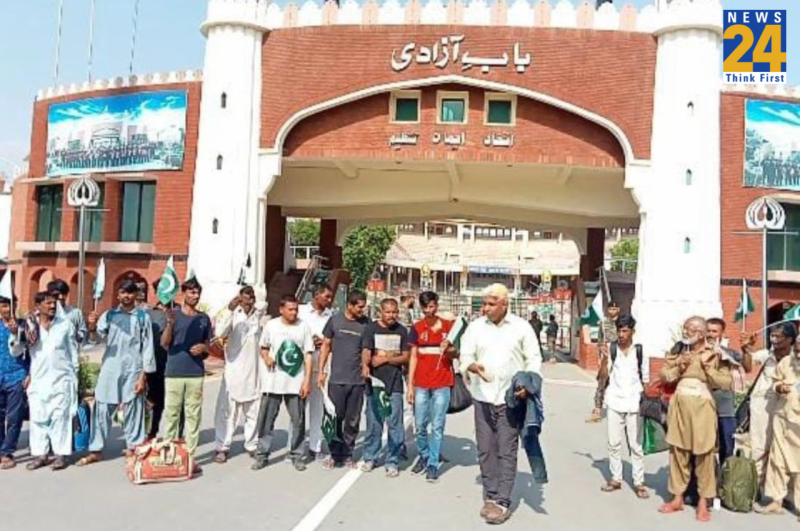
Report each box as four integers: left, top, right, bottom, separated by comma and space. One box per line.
18, 316, 79, 456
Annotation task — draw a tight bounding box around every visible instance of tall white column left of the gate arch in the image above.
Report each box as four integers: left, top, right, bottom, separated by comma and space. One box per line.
189, 0, 274, 311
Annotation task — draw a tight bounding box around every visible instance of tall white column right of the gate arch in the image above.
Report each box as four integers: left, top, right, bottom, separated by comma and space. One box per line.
626, 2, 722, 356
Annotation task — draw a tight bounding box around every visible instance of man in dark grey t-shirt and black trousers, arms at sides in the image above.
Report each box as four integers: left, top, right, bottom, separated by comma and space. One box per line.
317, 290, 369, 469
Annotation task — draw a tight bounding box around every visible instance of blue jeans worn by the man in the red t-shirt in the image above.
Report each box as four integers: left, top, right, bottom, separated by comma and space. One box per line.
414, 387, 450, 468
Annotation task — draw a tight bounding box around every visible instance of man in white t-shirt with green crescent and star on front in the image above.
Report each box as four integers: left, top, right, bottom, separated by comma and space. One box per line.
251, 295, 314, 472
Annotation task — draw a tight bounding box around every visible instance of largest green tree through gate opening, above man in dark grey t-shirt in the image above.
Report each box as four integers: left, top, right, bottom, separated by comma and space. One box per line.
342, 225, 397, 289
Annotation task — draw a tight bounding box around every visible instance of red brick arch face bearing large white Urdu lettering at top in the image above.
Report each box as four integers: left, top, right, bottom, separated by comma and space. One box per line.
261, 26, 656, 159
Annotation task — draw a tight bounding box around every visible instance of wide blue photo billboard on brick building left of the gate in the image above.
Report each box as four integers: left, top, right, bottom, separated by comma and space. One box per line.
46, 90, 186, 177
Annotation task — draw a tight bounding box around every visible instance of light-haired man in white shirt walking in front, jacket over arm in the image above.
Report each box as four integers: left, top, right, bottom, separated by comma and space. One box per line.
461, 284, 542, 524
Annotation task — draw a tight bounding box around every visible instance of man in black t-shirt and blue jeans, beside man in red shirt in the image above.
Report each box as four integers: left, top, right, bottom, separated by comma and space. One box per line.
362, 299, 411, 478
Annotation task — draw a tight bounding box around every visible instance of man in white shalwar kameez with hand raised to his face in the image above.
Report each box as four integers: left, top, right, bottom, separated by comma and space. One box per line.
214, 286, 264, 464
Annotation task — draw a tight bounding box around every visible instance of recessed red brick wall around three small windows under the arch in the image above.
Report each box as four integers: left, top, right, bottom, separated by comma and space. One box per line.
284, 85, 625, 167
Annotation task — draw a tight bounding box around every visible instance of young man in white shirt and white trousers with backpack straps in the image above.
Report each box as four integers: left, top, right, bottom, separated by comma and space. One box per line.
601, 315, 650, 500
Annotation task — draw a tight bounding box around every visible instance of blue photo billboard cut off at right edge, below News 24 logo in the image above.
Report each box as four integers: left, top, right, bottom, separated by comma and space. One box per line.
744, 100, 800, 190
